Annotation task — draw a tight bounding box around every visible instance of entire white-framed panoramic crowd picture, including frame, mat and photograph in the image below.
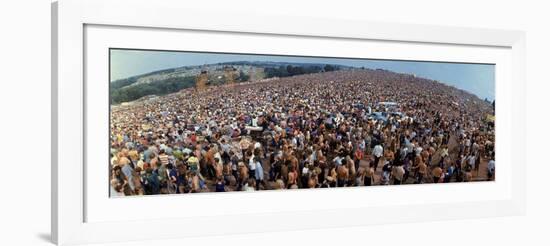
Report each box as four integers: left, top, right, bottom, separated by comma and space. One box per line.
52, 0, 526, 244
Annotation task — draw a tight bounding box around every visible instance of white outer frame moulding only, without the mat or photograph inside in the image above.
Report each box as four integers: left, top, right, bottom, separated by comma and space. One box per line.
51, 0, 526, 244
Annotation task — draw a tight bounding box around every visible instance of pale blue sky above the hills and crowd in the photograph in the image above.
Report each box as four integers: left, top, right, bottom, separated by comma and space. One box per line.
110, 49, 495, 100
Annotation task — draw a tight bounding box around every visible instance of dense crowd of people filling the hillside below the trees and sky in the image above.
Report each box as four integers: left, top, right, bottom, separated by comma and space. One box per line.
109, 69, 495, 196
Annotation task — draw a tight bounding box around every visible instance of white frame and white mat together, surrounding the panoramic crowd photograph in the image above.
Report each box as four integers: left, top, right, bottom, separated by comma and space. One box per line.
52, 0, 526, 245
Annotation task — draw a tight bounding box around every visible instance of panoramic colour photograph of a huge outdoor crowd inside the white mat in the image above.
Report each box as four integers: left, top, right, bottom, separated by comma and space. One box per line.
108, 49, 495, 197
